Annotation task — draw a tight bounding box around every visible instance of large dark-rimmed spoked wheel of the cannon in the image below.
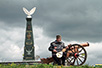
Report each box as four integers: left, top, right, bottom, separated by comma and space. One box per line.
66, 44, 87, 66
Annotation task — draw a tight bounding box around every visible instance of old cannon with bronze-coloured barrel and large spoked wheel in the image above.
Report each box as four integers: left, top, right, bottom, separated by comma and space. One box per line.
41, 43, 89, 66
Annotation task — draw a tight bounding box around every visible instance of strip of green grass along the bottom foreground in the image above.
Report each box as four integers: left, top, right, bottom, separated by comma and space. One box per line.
0, 63, 95, 68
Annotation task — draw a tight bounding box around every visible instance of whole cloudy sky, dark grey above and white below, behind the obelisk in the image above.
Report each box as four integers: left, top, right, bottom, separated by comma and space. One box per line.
0, 0, 102, 65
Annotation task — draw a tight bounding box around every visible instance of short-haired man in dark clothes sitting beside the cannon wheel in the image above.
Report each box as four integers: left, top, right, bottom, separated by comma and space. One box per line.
48, 35, 68, 65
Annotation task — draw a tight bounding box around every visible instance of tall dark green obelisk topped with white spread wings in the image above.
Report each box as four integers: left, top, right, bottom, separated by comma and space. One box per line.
23, 7, 36, 60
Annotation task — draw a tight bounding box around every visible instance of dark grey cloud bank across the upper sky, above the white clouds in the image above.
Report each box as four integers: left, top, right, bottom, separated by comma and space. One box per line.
0, 0, 102, 42
